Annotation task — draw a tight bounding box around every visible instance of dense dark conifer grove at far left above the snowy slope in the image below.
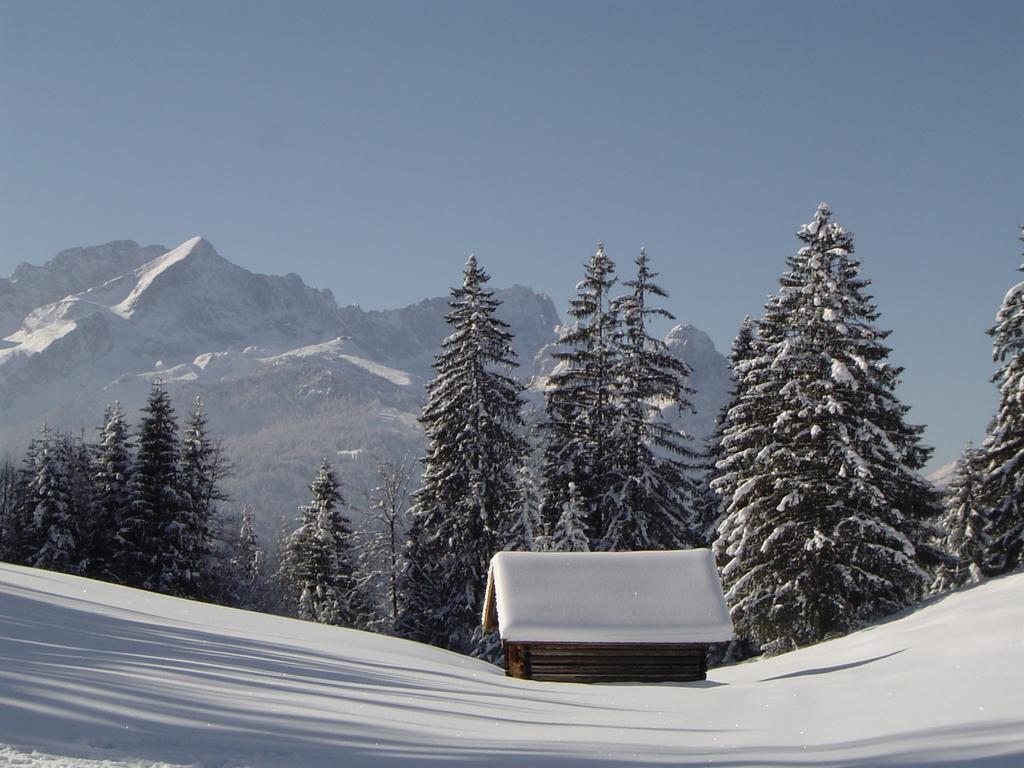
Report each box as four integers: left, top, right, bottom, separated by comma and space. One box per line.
0, 391, 233, 602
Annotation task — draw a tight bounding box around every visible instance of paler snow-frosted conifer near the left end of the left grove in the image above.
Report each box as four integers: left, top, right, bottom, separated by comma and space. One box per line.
28, 425, 82, 573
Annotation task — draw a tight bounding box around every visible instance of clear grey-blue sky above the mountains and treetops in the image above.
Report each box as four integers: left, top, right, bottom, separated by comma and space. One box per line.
0, 0, 1024, 473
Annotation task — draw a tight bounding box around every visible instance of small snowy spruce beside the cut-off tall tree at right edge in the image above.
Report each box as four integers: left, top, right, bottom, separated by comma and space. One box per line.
932, 442, 989, 592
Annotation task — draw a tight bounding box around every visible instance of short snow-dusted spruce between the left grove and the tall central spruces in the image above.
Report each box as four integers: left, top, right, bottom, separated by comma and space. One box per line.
281, 460, 359, 627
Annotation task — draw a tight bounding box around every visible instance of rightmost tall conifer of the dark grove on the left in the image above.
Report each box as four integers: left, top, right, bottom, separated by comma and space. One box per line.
176, 397, 230, 600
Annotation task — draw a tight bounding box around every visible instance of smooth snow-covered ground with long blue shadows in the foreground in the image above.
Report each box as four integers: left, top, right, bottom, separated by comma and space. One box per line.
0, 564, 1024, 768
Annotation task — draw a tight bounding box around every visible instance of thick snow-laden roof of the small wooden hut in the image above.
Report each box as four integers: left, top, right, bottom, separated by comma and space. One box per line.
483, 549, 732, 643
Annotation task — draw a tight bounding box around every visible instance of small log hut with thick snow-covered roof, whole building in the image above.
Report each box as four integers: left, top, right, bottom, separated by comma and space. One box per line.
483, 549, 732, 682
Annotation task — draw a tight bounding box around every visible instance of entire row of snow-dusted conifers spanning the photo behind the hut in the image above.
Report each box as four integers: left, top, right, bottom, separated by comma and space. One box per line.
0, 204, 1024, 657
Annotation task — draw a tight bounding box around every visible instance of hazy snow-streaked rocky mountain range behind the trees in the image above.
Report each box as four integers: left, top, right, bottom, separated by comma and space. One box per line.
0, 238, 728, 532
